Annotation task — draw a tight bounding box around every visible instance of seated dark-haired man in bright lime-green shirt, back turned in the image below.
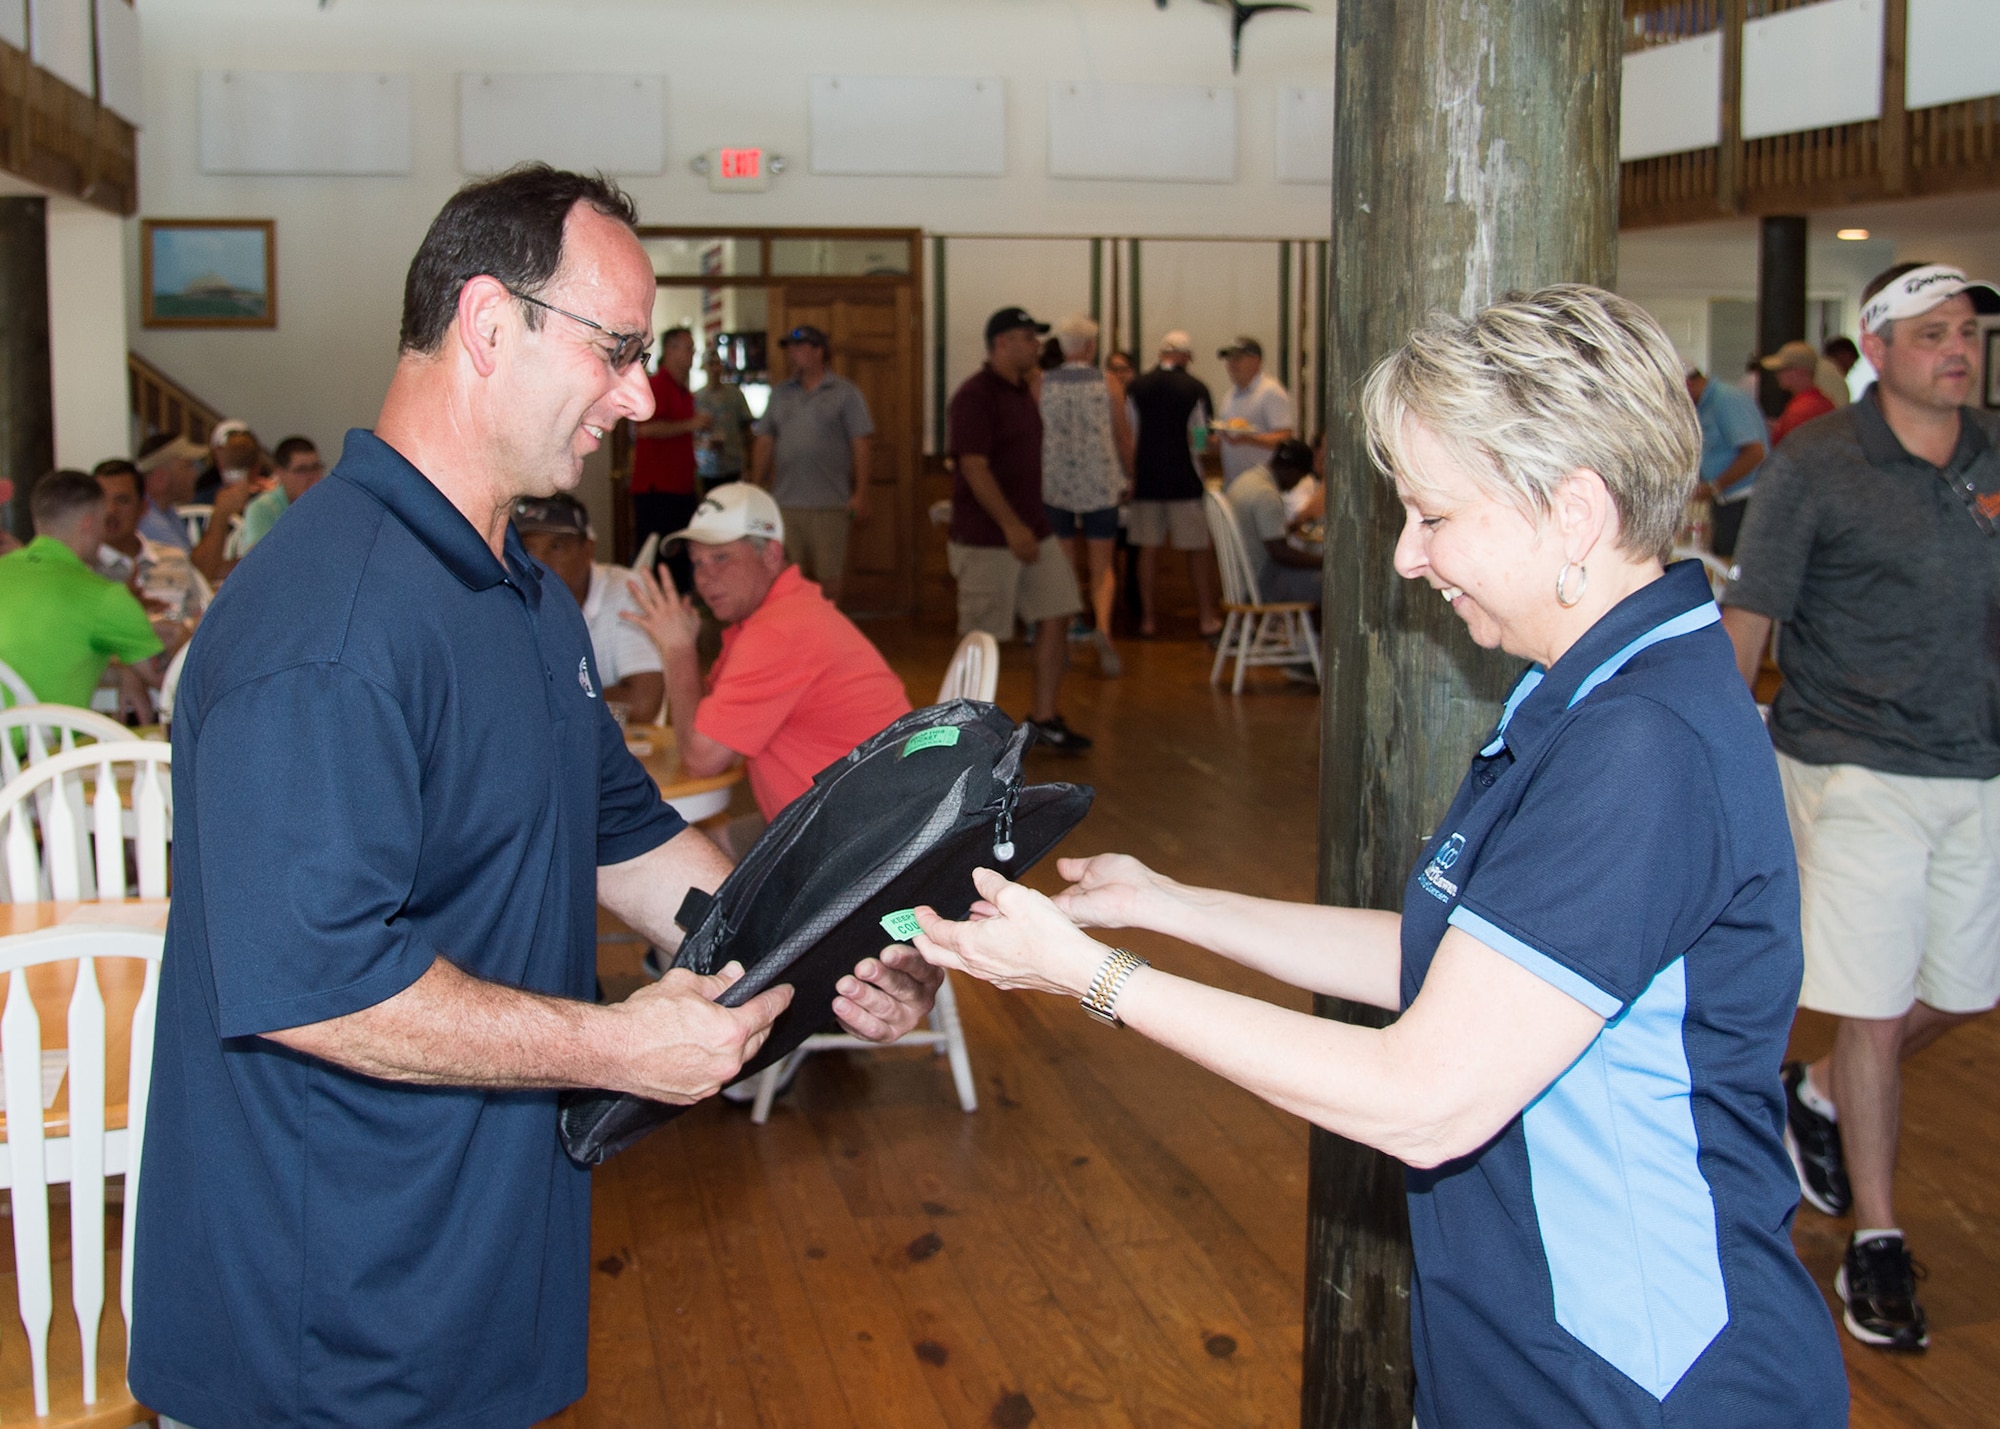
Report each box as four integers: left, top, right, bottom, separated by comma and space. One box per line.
0, 470, 162, 708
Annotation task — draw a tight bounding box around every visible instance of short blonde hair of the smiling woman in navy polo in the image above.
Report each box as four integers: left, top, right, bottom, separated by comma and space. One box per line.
1362, 282, 1702, 560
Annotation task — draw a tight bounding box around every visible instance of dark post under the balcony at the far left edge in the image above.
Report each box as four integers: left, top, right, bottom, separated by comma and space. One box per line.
0, 198, 56, 540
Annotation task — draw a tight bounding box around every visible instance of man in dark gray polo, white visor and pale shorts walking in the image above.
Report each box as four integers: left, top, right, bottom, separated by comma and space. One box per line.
1722, 264, 2000, 1351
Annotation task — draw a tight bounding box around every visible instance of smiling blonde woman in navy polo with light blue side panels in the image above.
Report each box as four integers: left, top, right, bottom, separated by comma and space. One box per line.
916, 284, 1848, 1429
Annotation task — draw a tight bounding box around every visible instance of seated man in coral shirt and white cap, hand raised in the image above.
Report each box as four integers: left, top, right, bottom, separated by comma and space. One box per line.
624, 482, 910, 859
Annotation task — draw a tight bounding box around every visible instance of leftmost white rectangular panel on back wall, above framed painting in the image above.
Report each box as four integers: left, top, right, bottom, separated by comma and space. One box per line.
202, 70, 410, 174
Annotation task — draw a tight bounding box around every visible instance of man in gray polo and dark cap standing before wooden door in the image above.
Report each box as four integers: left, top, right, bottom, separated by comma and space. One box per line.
750, 326, 874, 602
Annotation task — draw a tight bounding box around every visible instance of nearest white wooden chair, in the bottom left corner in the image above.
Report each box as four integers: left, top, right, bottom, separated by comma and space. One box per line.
0, 925, 164, 1429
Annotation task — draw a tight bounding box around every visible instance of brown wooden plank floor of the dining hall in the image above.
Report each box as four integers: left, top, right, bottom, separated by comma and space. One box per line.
550, 622, 2000, 1429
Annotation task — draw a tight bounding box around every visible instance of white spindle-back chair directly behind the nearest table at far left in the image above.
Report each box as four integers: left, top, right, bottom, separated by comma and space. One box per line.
0, 739, 174, 903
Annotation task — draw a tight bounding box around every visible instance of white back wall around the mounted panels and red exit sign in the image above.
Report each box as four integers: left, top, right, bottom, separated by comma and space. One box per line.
130, 0, 1334, 446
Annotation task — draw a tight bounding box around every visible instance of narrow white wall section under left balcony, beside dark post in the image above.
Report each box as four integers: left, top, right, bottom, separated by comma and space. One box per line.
48, 198, 132, 470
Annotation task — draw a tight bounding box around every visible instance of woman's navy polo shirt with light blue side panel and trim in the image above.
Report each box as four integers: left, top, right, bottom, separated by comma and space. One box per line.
1402, 560, 1848, 1429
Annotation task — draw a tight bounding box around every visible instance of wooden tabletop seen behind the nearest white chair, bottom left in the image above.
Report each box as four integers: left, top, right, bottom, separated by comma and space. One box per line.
0, 899, 168, 1137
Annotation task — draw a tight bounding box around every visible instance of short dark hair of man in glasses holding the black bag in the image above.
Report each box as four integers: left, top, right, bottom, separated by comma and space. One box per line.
400, 164, 638, 356
